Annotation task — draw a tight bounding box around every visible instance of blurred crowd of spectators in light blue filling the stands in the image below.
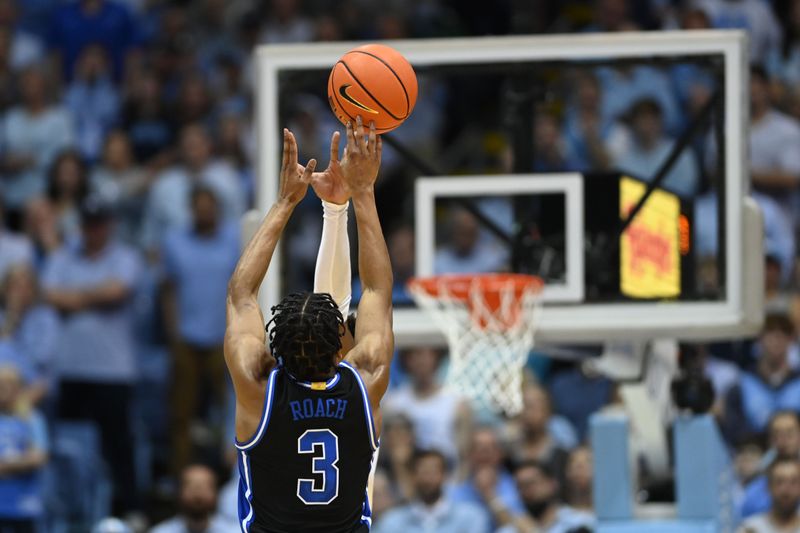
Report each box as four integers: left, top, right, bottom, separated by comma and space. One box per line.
0, 0, 800, 533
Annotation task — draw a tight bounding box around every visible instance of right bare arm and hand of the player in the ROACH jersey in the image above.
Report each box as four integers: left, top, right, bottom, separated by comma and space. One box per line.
342, 117, 394, 410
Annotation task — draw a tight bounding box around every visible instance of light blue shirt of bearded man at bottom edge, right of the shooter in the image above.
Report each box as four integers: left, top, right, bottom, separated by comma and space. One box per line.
372, 500, 491, 533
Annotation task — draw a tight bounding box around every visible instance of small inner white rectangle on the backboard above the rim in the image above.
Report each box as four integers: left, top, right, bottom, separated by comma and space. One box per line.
414, 173, 584, 303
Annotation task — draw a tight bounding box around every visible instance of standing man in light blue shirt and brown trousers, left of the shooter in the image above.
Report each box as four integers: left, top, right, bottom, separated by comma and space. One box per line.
162, 186, 240, 475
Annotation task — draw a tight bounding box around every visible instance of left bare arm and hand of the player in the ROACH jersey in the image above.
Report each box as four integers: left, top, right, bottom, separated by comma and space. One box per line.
225, 129, 316, 413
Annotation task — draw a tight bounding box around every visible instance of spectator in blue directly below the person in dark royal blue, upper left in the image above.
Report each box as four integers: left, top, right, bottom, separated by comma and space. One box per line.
64, 45, 120, 161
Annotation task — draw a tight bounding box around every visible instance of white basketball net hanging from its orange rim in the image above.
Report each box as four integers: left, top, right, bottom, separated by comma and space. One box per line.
408, 274, 543, 416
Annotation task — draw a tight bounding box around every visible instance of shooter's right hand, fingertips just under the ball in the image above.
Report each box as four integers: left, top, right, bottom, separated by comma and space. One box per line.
341, 115, 382, 194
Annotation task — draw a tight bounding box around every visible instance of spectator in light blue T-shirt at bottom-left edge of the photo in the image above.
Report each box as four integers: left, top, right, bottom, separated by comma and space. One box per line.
0, 363, 48, 532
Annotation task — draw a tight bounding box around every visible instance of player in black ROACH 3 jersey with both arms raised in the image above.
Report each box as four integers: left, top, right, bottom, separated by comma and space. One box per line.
225, 119, 394, 533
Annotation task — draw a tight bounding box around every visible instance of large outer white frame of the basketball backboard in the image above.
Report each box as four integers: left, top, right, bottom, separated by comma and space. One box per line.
256, 30, 763, 346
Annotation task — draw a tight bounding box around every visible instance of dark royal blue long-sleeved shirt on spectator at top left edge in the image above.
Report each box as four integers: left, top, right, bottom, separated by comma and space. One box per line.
49, 0, 139, 81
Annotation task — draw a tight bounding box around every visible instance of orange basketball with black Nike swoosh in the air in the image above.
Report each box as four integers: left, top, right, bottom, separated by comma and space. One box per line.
328, 44, 417, 133
